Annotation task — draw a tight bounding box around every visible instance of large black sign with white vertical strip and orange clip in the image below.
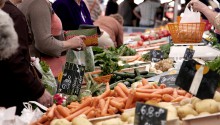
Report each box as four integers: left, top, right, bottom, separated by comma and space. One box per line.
175, 60, 220, 99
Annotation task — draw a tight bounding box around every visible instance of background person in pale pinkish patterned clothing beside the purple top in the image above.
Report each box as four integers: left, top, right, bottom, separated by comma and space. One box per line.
86, 0, 102, 22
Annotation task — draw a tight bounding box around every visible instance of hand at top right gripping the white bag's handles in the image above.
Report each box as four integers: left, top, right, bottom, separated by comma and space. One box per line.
188, 0, 208, 12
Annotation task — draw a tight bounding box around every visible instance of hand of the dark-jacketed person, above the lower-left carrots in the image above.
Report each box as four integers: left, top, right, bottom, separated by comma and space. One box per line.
37, 90, 53, 107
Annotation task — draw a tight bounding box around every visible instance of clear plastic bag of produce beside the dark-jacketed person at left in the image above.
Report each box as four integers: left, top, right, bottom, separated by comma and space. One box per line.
33, 58, 57, 95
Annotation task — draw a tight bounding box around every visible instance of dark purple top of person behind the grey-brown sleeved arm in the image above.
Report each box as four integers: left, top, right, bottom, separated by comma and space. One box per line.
52, 0, 93, 30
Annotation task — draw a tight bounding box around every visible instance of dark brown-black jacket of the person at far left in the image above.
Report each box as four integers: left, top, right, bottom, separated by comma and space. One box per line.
0, 1, 45, 115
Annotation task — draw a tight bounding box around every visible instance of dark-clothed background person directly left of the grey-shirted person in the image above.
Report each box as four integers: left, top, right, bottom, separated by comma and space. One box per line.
118, 0, 137, 26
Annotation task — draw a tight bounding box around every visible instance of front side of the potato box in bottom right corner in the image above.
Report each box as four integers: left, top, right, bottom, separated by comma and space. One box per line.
183, 113, 220, 125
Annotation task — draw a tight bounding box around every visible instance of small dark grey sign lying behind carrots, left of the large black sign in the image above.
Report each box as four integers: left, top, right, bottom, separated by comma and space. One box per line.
158, 74, 178, 88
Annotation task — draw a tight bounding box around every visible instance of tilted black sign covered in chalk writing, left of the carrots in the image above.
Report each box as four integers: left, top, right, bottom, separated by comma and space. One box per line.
59, 62, 85, 95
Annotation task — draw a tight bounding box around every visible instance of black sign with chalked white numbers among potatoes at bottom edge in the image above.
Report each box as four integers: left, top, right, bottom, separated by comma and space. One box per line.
134, 102, 167, 125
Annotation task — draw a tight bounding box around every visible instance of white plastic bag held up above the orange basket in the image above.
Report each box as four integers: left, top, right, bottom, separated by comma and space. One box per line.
180, 4, 201, 23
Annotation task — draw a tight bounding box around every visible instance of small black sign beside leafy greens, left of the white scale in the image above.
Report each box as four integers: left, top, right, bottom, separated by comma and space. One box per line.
150, 50, 163, 62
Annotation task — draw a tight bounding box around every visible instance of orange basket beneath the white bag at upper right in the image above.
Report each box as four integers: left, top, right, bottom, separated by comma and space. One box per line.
168, 18, 206, 43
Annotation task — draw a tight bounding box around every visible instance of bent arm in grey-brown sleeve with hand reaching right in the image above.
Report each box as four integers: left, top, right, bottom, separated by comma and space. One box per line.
29, 0, 84, 57
